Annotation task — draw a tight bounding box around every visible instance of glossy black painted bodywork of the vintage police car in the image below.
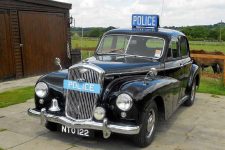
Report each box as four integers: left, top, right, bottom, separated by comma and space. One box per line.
35, 29, 199, 124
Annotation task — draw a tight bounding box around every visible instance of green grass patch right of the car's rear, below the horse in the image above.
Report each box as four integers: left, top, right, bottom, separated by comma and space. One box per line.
197, 77, 225, 95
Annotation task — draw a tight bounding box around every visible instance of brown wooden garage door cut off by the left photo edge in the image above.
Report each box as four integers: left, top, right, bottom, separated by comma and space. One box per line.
0, 10, 14, 80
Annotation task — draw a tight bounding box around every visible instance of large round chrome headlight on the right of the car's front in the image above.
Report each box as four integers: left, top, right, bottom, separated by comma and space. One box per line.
116, 93, 133, 111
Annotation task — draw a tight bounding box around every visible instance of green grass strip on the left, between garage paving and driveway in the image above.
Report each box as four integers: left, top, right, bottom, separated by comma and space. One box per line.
0, 86, 34, 108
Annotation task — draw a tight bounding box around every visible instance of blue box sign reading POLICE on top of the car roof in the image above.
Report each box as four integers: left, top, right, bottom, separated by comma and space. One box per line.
132, 14, 159, 28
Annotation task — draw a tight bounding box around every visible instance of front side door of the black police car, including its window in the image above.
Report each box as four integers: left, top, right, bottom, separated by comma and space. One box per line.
165, 37, 183, 110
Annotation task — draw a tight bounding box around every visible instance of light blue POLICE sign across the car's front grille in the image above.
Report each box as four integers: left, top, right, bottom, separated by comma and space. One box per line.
63, 80, 101, 94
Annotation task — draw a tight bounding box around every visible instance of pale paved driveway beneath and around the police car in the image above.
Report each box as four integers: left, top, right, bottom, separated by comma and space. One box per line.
0, 93, 225, 150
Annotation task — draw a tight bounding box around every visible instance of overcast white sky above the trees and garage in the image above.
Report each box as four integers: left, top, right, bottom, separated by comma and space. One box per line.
56, 0, 225, 28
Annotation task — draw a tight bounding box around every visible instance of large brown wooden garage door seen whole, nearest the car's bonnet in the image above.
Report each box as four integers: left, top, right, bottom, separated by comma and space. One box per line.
19, 11, 68, 76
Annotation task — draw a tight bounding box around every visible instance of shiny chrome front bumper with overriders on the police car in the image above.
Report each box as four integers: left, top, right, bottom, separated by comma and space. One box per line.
27, 108, 140, 138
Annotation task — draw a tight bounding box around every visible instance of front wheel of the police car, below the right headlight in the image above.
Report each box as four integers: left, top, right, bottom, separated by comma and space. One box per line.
134, 101, 158, 147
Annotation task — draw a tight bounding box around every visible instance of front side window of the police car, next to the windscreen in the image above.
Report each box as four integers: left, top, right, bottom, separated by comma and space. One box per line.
167, 38, 180, 59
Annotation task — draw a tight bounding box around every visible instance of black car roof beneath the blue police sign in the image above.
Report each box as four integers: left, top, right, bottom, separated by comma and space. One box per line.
105, 28, 185, 39
